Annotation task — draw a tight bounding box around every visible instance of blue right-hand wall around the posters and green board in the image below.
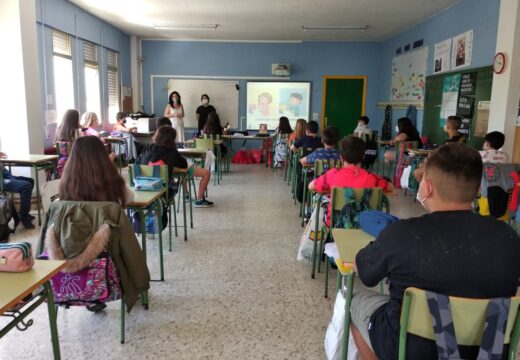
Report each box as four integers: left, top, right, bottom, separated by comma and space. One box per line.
377, 0, 500, 131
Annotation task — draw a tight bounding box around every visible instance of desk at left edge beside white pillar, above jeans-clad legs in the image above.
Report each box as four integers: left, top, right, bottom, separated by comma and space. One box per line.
0, 154, 58, 226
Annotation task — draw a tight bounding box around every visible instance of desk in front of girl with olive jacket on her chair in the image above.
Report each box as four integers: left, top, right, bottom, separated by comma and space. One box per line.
127, 188, 166, 290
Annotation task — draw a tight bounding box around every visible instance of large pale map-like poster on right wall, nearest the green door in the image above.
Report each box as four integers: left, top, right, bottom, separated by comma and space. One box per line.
390, 47, 428, 101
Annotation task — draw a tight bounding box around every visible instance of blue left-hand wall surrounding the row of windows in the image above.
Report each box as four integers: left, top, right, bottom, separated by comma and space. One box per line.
35, 0, 132, 145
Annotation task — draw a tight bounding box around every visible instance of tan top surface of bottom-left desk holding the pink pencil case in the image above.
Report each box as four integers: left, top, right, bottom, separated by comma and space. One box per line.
0, 260, 65, 314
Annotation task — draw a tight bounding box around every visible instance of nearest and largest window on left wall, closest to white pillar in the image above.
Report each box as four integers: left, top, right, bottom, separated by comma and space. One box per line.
52, 30, 75, 124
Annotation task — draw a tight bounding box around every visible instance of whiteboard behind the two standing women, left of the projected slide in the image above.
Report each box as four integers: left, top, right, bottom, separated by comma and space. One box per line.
167, 78, 239, 129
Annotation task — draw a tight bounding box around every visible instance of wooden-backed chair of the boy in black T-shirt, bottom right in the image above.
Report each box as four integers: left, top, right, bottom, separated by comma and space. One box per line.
399, 287, 520, 360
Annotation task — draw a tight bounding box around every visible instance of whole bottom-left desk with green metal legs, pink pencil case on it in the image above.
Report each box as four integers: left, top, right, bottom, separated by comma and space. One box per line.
0, 260, 65, 359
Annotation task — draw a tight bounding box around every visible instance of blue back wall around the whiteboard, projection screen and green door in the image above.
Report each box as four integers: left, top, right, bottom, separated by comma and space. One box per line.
142, 40, 381, 128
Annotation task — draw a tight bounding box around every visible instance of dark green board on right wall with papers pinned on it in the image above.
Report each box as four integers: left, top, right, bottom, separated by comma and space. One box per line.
422, 66, 493, 149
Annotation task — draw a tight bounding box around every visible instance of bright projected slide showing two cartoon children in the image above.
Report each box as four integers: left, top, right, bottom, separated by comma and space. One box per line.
247, 82, 310, 130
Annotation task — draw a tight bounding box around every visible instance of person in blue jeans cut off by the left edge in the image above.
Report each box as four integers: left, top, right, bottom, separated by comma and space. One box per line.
0, 151, 34, 229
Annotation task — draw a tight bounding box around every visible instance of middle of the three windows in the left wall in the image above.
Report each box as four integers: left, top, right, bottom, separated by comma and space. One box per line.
83, 42, 103, 119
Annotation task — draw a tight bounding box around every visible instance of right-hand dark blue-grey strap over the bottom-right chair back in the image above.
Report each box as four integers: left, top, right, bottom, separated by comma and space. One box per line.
477, 298, 511, 360
